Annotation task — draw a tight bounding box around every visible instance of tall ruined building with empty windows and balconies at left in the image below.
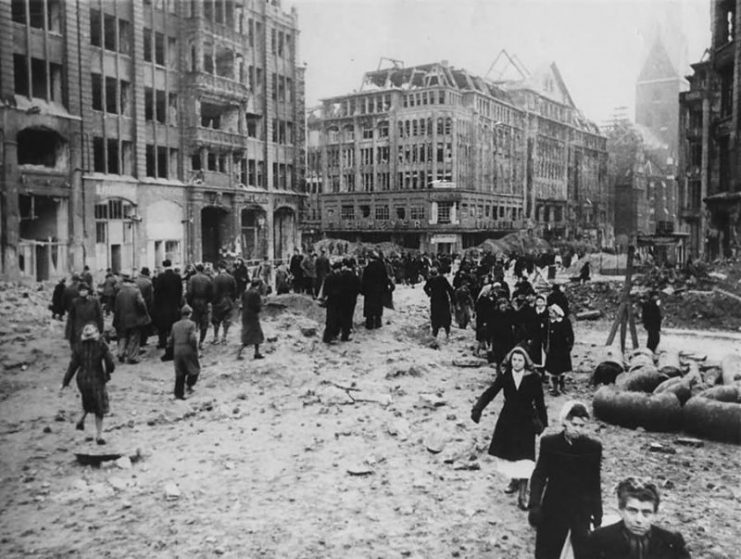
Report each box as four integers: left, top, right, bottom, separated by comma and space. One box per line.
0, 0, 304, 279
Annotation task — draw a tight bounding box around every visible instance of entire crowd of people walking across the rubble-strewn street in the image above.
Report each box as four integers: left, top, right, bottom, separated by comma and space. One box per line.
50, 249, 689, 559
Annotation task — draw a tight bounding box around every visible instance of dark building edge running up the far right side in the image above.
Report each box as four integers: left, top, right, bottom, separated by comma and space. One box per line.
677, 0, 741, 259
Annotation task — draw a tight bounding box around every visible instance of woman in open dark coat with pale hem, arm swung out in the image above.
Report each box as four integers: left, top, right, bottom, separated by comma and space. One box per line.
471, 346, 548, 510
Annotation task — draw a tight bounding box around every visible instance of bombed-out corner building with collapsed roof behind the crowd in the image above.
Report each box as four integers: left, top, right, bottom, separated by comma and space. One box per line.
307, 62, 612, 252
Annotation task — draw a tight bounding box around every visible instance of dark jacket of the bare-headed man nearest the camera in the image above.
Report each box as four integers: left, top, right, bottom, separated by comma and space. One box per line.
585, 520, 690, 559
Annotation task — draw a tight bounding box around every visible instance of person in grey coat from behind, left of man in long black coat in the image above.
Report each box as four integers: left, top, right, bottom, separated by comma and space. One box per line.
113, 274, 151, 365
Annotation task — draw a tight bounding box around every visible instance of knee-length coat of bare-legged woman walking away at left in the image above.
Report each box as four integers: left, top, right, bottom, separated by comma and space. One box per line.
62, 339, 116, 416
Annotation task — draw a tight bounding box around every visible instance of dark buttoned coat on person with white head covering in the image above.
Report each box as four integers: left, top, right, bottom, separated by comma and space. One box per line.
530, 432, 602, 529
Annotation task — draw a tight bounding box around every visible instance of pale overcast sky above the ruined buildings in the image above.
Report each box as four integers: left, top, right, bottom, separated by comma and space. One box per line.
284, 0, 710, 123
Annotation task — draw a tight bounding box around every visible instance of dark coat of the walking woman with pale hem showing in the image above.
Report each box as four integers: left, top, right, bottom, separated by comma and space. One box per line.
473, 368, 548, 460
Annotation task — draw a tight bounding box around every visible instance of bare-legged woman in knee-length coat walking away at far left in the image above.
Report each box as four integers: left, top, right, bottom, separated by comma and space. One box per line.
62, 322, 116, 444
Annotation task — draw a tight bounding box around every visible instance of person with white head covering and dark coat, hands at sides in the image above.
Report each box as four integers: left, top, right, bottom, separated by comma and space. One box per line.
528, 401, 602, 559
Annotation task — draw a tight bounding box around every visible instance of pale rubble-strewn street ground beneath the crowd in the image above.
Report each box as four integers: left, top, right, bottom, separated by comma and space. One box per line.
0, 286, 741, 558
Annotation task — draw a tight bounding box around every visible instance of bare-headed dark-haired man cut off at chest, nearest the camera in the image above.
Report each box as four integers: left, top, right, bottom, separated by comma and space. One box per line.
584, 477, 690, 559
